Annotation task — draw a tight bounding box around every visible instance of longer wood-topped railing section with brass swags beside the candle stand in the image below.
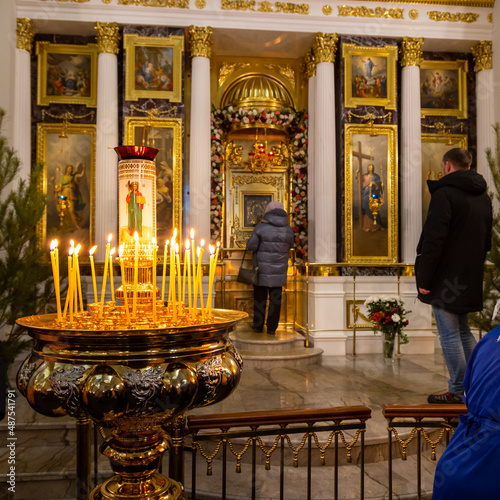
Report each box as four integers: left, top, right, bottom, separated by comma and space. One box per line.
182, 406, 371, 500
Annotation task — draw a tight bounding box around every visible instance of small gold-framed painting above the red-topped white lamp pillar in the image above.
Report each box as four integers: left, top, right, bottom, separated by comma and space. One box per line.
123, 35, 184, 102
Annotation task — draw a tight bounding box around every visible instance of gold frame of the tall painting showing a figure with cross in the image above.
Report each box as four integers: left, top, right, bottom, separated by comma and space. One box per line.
344, 124, 398, 264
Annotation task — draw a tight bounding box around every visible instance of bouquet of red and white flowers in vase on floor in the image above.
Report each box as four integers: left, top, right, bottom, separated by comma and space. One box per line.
365, 296, 411, 358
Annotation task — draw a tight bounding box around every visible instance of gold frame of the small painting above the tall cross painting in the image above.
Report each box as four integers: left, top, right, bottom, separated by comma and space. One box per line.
342, 43, 398, 109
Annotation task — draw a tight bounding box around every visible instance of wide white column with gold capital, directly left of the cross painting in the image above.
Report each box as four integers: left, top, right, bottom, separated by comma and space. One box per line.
309, 33, 337, 263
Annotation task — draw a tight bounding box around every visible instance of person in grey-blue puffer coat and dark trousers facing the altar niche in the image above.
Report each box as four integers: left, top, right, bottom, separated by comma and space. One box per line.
247, 201, 294, 335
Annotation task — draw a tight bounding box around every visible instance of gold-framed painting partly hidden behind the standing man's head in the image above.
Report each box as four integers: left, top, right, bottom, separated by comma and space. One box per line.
422, 134, 467, 224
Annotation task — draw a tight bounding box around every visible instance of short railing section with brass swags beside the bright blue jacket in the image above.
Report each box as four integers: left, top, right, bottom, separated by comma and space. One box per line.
382, 404, 467, 500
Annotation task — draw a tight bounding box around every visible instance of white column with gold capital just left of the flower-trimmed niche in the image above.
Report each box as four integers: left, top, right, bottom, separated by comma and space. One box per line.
189, 26, 212, 252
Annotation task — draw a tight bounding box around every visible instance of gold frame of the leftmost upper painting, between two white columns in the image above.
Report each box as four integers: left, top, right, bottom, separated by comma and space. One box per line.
36, 42, 98, 108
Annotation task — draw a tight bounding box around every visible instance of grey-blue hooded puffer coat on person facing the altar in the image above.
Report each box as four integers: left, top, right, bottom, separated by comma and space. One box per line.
247, 208, 294, 287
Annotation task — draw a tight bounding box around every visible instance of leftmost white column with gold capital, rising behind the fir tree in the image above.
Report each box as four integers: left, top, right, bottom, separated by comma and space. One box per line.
12, 18, 34, 179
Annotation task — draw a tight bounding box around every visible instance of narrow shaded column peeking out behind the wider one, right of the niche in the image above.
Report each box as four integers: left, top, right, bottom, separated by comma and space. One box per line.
306, 50, 316, 262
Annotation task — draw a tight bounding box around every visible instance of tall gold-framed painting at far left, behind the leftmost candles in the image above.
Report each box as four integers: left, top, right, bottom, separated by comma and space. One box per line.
37, 123, 96, 256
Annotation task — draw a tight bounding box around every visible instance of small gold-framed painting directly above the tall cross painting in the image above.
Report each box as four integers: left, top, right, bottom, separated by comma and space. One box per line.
342, 43, 398, 109
